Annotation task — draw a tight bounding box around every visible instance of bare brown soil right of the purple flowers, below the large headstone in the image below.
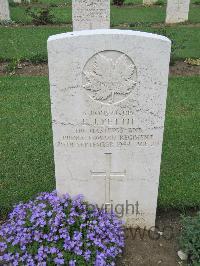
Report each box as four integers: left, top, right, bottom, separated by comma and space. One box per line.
117, 212, 186, 266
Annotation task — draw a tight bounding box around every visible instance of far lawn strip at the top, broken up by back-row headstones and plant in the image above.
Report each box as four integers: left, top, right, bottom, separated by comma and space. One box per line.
11, 5, 200, 25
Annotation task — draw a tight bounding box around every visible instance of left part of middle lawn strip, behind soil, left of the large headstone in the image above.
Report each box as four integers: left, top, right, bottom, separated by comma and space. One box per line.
0, 27, 70, 61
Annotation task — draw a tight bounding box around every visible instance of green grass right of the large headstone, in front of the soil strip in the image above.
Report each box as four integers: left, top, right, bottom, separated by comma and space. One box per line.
159, 77, 200, 208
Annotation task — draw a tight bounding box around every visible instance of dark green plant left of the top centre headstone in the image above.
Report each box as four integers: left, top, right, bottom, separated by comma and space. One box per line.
26, 7, 55, 25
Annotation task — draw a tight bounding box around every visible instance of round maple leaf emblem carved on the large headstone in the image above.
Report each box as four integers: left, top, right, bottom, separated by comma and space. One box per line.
83, 51, 136, 104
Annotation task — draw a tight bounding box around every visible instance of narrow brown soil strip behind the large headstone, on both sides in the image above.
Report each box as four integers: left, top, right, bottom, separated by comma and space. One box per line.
0, 61, 200, 76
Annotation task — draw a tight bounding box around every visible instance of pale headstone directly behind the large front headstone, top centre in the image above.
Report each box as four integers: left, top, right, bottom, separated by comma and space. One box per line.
72, 0, 110, 31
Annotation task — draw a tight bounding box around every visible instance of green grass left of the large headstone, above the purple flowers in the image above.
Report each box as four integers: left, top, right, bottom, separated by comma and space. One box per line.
0, 77, 55, 218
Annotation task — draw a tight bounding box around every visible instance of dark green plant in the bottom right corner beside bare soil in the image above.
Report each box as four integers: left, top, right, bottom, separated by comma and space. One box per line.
180, 212, 200, 266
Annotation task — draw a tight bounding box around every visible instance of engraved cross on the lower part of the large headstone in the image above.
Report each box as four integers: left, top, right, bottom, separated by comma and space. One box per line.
90, 153, 126, 205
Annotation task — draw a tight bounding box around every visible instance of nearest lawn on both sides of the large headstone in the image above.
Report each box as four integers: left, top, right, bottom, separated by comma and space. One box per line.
0, 77, 200, 217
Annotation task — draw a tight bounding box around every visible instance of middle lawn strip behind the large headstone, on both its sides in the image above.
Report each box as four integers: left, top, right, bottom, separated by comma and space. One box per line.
0, 26, 200, 62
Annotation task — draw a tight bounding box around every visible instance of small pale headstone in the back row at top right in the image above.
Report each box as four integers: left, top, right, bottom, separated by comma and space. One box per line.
166, 0, 190, 24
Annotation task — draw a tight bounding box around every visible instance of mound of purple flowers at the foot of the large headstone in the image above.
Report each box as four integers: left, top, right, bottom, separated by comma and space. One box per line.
0, 192, 124, 266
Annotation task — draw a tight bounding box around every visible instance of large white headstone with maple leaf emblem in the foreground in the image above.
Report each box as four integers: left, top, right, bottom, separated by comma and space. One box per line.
48, 30, 170, 227
